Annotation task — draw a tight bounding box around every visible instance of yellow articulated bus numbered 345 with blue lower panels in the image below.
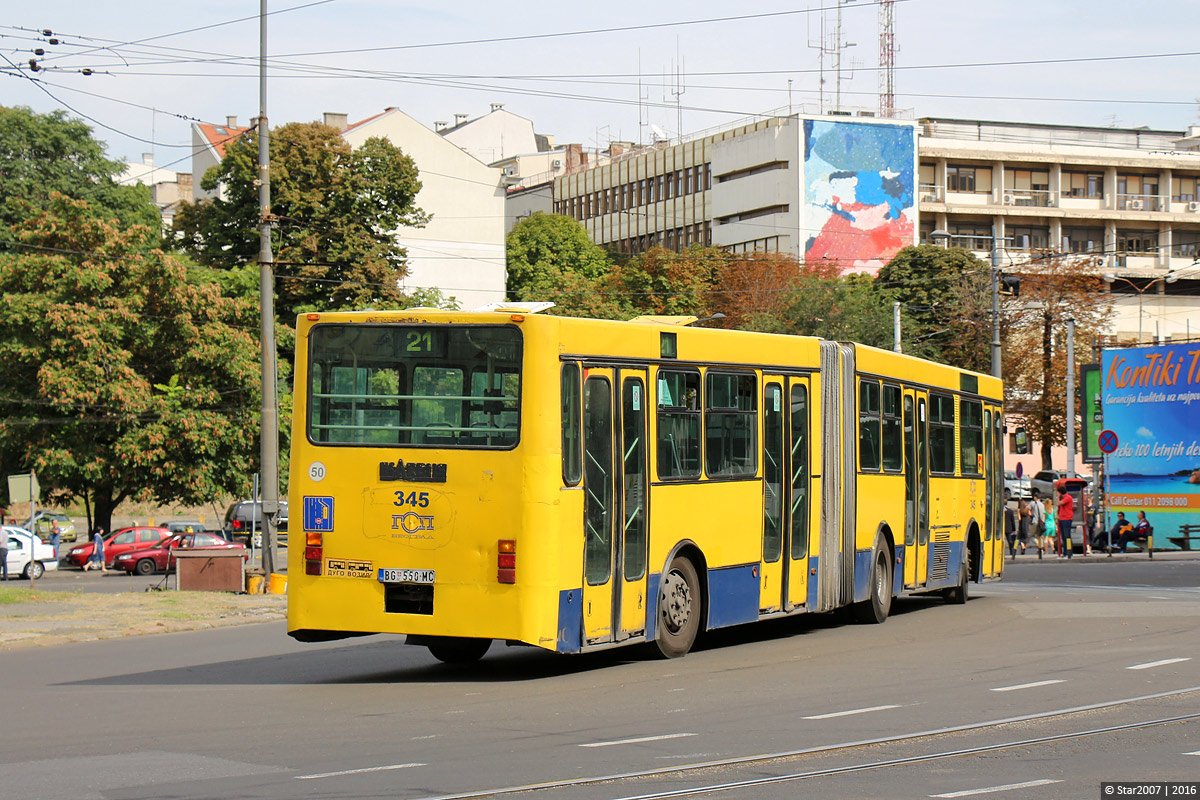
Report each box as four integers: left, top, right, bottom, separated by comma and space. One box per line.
288, 306, 1004, 662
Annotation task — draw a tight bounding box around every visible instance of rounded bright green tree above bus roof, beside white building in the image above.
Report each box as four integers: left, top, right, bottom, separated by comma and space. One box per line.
505, 211, 612, 306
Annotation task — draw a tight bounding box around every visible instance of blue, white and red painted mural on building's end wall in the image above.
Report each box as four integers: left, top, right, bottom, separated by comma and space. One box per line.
804, 120, 917, 272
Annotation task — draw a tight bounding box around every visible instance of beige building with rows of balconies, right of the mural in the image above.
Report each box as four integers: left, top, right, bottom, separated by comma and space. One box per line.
917, 119, 1200, 342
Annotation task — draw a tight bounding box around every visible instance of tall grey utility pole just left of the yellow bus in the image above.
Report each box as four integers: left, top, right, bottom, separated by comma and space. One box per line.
258, 0, 280, 576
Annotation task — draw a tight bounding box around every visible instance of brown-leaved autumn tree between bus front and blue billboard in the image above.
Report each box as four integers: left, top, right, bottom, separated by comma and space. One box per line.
1002, 252, 1112, 469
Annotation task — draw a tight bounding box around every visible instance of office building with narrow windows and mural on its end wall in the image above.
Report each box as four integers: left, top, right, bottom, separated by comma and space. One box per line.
554, 115, 917, 270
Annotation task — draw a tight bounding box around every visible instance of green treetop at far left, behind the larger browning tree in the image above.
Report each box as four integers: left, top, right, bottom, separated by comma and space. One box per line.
0, 107, 161, 241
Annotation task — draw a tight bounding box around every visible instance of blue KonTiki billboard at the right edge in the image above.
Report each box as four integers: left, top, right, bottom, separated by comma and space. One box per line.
1102, 342, 1200, 549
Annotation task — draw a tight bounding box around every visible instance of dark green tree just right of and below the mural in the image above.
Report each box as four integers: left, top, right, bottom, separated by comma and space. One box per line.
876, 245, 991, 372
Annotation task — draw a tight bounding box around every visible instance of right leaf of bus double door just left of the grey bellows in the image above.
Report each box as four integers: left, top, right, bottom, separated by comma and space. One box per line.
784, 378, 812, 610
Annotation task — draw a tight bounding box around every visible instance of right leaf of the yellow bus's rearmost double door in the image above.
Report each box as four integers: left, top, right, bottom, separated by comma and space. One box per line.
617, 369, 652, 640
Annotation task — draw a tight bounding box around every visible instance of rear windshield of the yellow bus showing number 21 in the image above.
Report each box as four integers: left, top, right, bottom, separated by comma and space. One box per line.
308, 325, 521, 447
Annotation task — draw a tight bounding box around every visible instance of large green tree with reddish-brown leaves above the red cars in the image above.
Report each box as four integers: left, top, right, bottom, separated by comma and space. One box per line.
0, 194, 259, 528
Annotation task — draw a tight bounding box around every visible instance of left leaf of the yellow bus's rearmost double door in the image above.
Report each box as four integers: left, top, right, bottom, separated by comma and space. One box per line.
583, 369, 617, 644
